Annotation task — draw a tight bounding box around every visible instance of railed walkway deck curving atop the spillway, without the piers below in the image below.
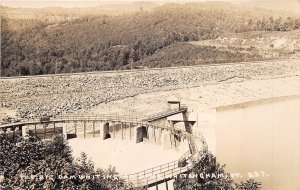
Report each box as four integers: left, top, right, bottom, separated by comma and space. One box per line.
0, 115, 207, 188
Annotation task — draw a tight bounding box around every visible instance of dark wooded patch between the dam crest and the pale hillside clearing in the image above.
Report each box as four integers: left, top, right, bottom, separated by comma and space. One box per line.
137, 42, 263, 68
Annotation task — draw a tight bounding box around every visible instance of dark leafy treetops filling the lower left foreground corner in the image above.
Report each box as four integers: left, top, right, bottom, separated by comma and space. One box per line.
0, 134, 131, 190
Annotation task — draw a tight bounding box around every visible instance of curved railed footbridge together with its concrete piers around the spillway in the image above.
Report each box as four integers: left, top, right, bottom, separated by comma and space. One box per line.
0, 115, 207, 189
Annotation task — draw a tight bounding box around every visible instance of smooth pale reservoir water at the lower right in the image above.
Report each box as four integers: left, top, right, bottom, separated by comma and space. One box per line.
215, 95, 300, 190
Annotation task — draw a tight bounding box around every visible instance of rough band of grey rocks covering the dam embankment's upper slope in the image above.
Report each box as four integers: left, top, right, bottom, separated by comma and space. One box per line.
0, 59, 300, 122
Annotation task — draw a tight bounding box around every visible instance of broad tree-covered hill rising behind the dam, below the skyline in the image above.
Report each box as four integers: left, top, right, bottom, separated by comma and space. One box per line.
1, 3, 300, 76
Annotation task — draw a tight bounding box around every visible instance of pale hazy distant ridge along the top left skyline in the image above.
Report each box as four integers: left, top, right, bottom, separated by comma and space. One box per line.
1, 1, 157, 18
